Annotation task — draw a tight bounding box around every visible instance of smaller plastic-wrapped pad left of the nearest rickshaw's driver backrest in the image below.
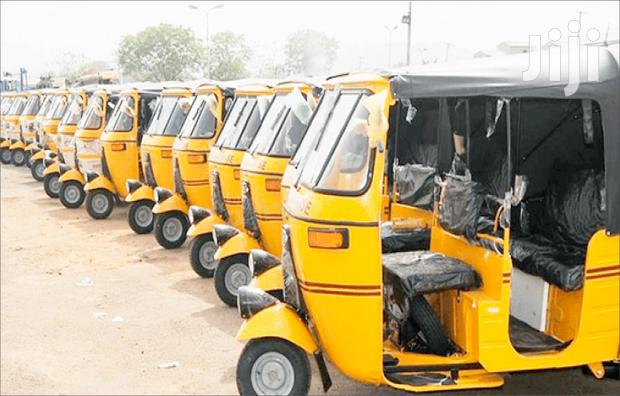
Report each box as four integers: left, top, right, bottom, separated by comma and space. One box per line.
394, 164, 435, 209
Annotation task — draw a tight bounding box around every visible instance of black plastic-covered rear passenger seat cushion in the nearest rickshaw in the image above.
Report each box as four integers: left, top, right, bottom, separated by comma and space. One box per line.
510, 235, 585, 291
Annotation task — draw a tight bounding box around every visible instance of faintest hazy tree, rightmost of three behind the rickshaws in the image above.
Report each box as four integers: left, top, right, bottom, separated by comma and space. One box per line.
284, 30, 338, 76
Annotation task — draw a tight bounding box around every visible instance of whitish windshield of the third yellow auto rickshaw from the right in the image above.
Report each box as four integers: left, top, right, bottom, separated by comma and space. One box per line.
250, 88, 314, 157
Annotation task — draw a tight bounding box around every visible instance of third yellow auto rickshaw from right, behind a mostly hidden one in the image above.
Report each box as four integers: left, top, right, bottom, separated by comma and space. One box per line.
209, 82, 321, 306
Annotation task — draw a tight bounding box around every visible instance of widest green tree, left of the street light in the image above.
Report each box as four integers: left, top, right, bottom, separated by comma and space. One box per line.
118, 23, 204, 81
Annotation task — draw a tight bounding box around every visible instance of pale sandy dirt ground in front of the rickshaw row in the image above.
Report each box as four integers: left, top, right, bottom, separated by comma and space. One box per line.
0, 165, 620, 395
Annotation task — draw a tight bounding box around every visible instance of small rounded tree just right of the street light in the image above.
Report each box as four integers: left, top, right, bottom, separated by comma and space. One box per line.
206, 31, 252, 81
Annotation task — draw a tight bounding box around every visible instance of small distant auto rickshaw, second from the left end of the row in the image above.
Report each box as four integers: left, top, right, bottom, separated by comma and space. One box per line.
9, 91, 44, 166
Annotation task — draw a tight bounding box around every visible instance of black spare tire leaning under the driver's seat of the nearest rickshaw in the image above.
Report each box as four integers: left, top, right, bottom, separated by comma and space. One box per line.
409, 295, 452, 356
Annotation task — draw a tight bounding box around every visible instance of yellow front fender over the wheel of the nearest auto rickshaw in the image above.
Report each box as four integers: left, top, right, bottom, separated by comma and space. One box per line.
237, 303, 319, 354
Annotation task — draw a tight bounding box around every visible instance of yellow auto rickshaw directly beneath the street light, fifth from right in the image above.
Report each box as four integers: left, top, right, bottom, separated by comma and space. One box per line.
152, 82, 234, 249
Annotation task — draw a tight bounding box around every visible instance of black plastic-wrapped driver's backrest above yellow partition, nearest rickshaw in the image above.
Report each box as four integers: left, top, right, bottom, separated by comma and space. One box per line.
439, 177, 484, 240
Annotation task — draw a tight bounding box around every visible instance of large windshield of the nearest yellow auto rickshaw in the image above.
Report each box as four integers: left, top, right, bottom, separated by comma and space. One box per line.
300, 92, 370, 192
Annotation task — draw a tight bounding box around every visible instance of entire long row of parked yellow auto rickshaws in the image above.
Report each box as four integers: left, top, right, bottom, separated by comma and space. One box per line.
1, 46, 620, 395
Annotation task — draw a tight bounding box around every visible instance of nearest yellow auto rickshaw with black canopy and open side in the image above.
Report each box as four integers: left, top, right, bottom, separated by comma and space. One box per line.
237, 48, 620, 395
